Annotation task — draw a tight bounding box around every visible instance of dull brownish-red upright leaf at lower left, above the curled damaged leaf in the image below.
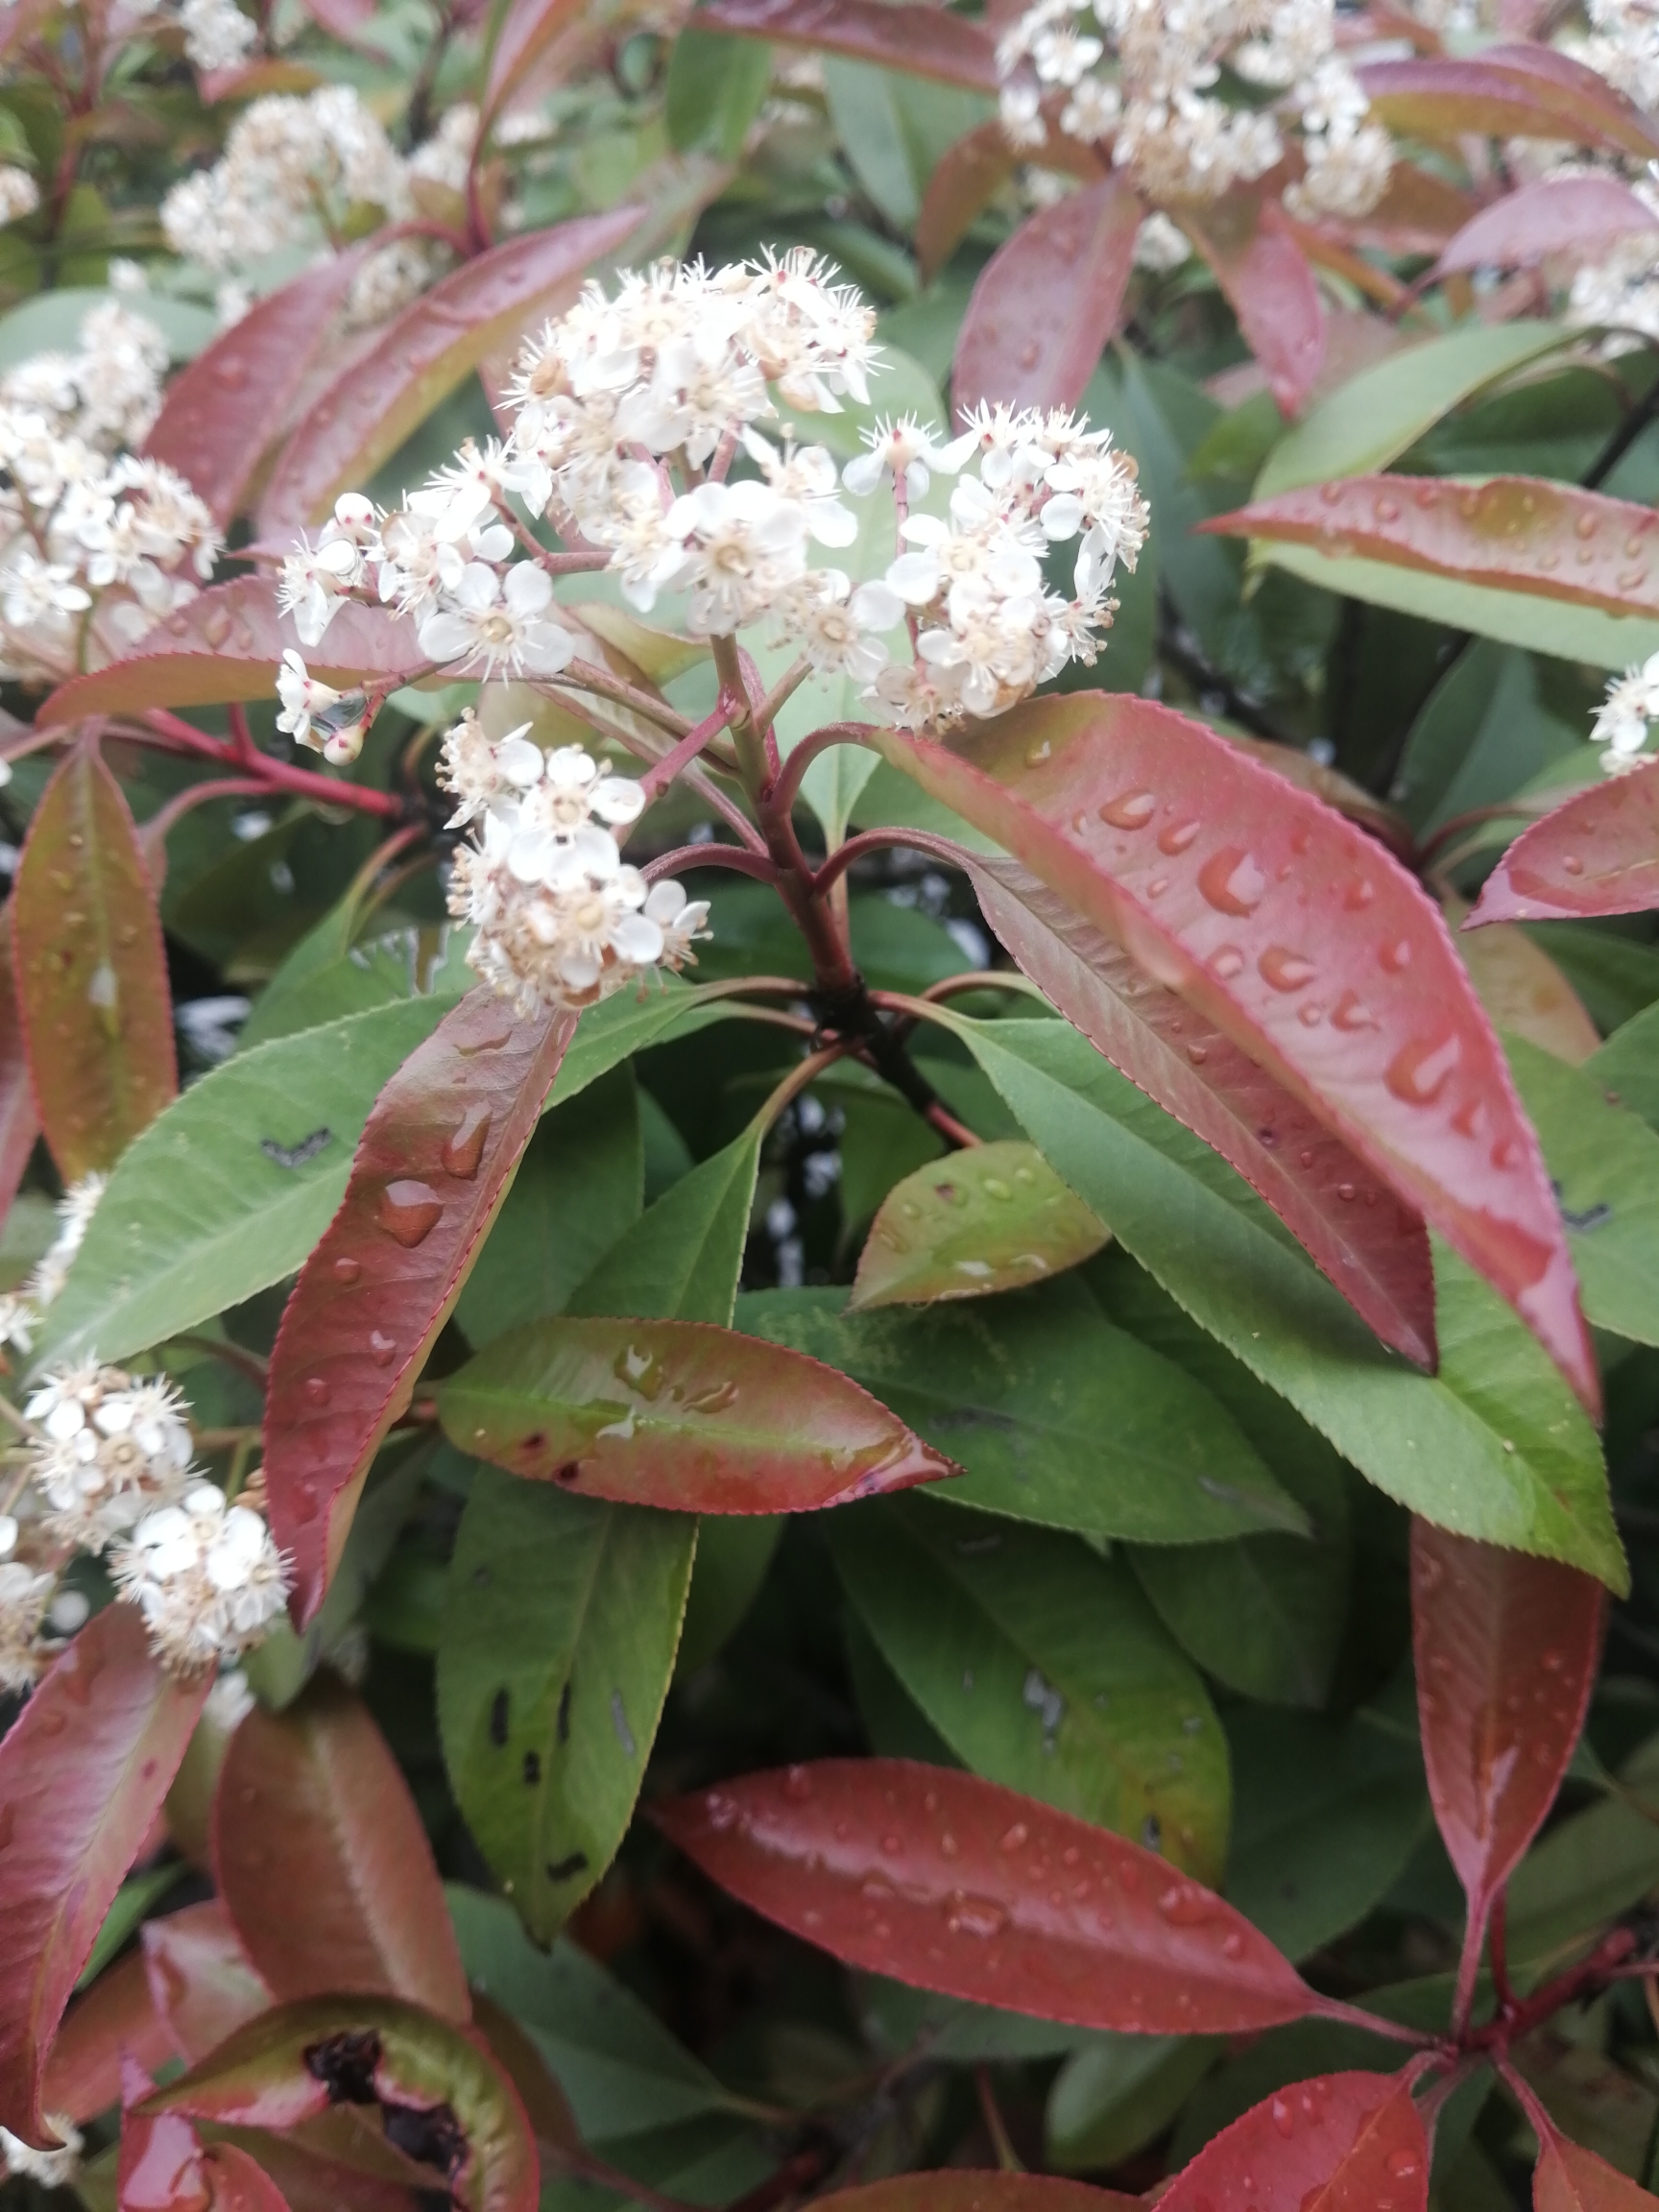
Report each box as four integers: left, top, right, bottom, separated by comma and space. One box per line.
212, 1676, 471, 2020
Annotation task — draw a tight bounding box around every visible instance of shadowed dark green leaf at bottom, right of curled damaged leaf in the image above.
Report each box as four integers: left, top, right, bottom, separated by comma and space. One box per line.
446, 1887, 730, 2144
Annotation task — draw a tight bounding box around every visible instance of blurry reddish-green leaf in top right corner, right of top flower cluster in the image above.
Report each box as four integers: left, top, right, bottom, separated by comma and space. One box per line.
1358, 46, 1659, 161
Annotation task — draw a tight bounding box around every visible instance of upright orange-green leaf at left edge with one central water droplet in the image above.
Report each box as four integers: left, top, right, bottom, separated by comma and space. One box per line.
12, 743, 180, 1181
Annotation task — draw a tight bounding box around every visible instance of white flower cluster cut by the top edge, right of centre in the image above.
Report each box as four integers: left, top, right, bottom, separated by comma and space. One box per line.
998, 0, 1394, 219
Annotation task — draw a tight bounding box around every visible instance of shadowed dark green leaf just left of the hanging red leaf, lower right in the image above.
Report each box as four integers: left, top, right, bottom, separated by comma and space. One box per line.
1228, 1698, 1429, 1960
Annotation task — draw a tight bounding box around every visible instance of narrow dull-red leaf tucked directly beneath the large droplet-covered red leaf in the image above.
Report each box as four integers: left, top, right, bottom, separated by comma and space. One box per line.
969, 860, 1435, 1367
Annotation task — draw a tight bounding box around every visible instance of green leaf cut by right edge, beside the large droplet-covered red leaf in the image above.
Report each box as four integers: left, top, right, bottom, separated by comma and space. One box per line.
1504, 1038, 1659, 1345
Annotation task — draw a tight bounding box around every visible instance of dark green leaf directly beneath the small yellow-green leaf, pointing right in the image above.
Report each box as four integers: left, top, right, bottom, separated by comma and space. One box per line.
736, 1291, 1303, 1544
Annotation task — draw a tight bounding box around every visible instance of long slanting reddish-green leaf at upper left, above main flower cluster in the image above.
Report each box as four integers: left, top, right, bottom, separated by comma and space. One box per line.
259, 208, 641, 538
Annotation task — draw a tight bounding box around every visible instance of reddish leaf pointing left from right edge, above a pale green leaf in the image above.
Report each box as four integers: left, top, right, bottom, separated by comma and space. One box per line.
1199, 475, 1659, 615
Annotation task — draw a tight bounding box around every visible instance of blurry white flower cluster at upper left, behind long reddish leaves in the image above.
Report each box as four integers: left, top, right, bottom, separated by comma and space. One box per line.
161, 86, 478, 325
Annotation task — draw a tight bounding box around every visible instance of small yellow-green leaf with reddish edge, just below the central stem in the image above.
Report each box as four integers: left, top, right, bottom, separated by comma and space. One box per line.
847, 1137, 1111, 1311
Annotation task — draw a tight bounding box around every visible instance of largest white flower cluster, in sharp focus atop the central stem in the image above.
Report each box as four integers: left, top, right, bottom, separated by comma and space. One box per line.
278, 250, 1145, 761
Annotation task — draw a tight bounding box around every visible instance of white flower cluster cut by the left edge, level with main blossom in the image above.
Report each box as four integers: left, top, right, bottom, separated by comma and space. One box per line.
0, 301, 219, 682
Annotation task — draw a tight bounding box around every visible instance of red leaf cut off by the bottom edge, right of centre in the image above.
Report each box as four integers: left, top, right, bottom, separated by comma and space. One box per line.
1159, 2073, 1429, 2212
